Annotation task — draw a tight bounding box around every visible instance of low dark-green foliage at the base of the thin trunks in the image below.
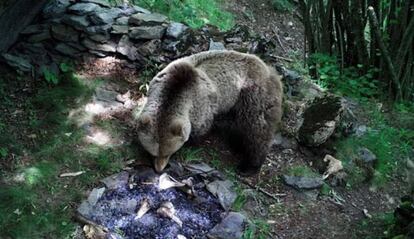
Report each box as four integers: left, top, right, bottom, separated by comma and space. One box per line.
310, 53, 380, 99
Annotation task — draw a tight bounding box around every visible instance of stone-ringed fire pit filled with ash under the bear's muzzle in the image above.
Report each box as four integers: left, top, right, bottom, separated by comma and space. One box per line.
78, 164, 245, 238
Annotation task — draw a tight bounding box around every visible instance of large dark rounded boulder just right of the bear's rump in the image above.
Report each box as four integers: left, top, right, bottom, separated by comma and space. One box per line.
298, 95, 343, 146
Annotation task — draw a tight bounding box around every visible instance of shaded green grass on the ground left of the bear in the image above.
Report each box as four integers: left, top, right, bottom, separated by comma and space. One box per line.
0, 69, 132, 238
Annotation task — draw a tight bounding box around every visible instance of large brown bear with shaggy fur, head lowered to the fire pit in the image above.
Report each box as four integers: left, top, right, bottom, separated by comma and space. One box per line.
137, 51, 283, 174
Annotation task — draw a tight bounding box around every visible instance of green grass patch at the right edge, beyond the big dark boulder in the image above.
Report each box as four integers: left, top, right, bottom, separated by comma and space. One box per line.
337, 103, 414, 187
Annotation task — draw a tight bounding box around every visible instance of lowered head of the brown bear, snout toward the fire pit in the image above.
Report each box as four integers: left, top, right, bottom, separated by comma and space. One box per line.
138, 114, 191, 172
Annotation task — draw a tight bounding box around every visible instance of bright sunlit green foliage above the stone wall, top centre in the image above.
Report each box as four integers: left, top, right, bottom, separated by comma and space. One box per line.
134, 0, 234, 30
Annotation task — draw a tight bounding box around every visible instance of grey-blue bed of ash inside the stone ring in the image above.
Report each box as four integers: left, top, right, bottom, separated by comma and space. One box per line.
85, 173, 224, 239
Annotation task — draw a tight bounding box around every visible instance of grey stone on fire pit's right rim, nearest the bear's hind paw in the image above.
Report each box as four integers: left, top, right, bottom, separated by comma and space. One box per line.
206, 180, 237, 211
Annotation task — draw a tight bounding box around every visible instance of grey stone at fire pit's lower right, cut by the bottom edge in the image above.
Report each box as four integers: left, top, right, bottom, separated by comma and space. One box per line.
208, 212, 246, 239
